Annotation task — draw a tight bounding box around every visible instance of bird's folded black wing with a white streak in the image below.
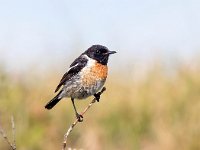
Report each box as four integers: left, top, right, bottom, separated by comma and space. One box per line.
55, 55, 88, 92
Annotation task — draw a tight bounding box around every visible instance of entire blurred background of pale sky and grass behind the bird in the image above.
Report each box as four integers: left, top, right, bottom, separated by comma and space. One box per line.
0, 0, 200, 150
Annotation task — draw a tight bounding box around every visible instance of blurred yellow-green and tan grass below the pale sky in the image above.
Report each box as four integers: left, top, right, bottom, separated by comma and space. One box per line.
0, 66, 200, 150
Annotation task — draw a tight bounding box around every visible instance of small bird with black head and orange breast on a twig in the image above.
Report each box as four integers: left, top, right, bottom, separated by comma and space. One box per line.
45, 45, 116, 122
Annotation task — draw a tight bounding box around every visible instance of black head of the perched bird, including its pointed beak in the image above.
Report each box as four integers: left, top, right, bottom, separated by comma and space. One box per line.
84, 45, 116, 65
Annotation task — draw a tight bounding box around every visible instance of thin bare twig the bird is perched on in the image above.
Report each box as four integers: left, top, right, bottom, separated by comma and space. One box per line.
62, 87, 106, 150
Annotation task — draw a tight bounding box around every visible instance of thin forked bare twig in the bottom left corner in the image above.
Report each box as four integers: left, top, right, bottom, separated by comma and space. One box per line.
0, 116, 16, 150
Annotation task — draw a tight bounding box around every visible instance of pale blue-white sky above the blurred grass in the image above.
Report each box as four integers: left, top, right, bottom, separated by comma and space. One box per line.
0, 0, 200, 71
